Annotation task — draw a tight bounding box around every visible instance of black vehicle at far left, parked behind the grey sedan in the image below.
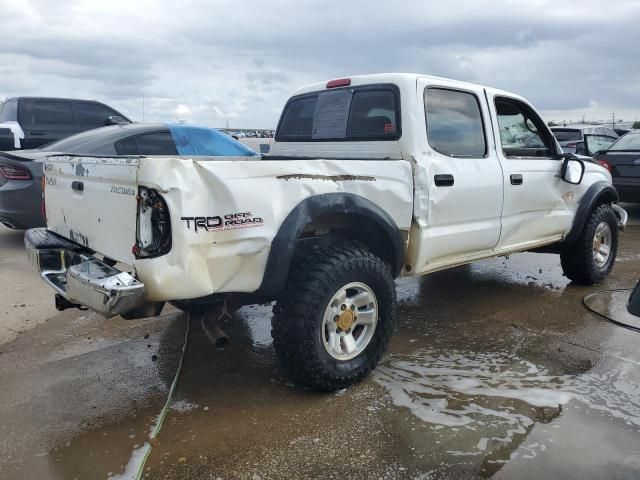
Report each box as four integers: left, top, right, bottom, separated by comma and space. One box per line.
0, 97, 131, 151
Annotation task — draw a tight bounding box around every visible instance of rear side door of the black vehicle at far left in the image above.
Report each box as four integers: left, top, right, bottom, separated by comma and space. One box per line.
21, 98, 77, 148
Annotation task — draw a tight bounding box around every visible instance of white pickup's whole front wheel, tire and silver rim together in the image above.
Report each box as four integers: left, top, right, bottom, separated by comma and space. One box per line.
560, 204, 618, 285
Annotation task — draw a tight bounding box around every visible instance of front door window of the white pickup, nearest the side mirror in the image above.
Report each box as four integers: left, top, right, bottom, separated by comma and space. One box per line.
495, 97, 555, 158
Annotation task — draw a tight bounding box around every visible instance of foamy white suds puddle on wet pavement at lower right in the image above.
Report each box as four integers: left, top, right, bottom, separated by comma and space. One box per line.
372, 349, 640, 475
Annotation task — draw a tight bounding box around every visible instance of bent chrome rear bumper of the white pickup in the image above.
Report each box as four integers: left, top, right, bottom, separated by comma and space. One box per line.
24, 228, 146, 318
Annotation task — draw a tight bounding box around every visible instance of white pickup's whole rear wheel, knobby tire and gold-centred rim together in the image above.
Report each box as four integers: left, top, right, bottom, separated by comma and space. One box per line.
271, 247, 396, 391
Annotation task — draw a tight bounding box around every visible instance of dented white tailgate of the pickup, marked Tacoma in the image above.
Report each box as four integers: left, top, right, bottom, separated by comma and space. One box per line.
44, 156, 139, 264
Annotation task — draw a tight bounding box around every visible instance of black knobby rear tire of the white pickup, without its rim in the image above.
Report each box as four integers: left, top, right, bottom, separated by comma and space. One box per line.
271, 246, 396, 391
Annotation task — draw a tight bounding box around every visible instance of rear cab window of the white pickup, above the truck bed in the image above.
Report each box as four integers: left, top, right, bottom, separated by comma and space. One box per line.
275, 84, 401, 142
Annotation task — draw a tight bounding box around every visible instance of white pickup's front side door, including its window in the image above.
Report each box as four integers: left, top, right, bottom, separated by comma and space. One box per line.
487, 89, 575, 251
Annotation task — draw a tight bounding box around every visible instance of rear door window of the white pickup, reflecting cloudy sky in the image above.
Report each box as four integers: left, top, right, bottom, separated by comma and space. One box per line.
424, 88, 487, 157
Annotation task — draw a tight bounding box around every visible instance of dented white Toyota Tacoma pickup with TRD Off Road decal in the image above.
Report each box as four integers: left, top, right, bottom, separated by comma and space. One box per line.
25, 74, 627, 390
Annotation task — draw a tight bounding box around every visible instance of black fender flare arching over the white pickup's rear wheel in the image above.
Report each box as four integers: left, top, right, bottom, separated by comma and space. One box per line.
256, 193, 404, 297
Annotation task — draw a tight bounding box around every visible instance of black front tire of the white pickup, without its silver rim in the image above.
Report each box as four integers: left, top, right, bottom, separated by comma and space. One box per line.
560, 203, 618, 285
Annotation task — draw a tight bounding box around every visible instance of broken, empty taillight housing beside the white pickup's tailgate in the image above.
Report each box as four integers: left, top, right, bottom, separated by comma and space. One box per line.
131, 187, 171, 258
